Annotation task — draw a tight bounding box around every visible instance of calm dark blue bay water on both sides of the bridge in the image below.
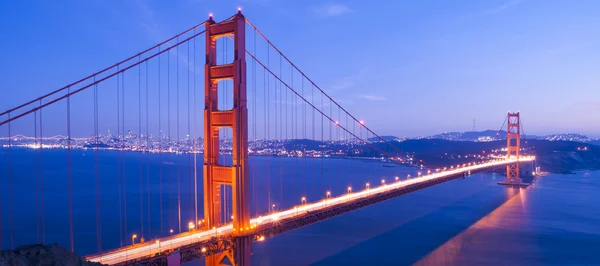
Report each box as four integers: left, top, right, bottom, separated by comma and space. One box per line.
0, 148, 600, 265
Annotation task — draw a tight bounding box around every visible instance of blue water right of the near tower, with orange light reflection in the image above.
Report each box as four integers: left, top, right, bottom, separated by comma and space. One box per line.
262, 171, 600, 265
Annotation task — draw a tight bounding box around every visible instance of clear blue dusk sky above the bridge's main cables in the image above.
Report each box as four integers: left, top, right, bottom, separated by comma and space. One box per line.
0, 0, 600, 137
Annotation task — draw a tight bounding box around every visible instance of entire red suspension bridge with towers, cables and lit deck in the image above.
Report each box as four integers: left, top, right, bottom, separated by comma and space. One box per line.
0, 11, 535, 266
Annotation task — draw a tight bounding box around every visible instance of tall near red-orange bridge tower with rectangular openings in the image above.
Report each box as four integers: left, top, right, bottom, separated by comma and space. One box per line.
203, 12, 251, 266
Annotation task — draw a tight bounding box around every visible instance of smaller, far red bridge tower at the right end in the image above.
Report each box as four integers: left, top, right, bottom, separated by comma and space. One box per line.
506, 112, 521, 184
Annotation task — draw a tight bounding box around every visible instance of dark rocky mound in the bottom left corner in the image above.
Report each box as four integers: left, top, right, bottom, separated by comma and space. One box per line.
0, 244, 103, 266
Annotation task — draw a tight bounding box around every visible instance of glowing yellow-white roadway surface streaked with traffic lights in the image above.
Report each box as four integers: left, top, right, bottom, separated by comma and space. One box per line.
85, 156, 535, 265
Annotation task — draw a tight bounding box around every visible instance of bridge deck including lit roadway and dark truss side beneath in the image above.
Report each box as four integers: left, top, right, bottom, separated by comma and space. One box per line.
85, 156, 535, 265
